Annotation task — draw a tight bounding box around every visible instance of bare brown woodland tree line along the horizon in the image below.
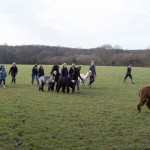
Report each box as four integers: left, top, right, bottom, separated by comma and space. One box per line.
0, 44, 150, 67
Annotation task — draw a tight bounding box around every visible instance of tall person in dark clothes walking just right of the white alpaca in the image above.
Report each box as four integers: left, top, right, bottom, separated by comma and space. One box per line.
88, 61, 96, 88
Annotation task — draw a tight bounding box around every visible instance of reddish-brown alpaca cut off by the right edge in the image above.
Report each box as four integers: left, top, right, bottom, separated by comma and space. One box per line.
137, 86, 150, 112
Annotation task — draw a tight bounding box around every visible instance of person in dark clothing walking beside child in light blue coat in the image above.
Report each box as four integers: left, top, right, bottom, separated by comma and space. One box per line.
9, 62, 18, 85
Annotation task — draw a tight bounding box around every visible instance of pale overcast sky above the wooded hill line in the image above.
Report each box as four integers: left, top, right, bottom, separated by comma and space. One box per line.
0, 0, 150, 49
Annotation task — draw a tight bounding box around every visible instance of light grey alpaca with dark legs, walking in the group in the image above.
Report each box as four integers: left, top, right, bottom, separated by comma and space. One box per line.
39, 71, 57, 91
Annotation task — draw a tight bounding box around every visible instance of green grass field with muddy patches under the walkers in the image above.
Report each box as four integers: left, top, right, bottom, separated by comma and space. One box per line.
0, 65, 150, 150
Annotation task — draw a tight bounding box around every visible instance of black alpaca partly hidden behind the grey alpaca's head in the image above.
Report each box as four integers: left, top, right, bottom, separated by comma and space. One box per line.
50, 65, 60, 91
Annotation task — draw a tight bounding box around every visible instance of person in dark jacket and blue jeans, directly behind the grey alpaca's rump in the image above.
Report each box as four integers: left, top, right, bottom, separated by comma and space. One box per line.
31, 64, 39, 85
